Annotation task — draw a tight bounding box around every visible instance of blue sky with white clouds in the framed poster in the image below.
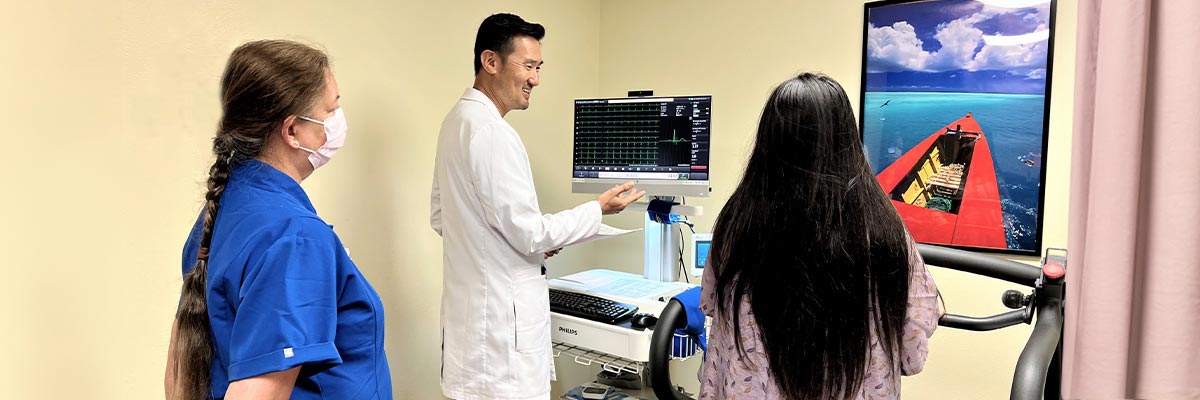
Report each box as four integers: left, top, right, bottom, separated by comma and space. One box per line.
866, 0, 1050, 94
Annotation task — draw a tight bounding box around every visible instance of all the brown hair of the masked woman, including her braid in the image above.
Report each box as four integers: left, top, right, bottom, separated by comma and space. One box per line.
172, 40, 329, 400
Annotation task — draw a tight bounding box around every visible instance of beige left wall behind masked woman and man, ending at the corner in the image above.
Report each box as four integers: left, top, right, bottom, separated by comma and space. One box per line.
0, 0, 599, 399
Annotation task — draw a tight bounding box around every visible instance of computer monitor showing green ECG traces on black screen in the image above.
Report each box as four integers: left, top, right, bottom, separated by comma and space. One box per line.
571, 96, 713, 197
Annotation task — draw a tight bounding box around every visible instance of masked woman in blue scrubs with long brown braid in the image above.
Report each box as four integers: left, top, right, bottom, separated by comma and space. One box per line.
166, 41, 391, 400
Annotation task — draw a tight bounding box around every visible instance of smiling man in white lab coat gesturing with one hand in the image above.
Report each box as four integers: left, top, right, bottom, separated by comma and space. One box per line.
430, 14, 643, 400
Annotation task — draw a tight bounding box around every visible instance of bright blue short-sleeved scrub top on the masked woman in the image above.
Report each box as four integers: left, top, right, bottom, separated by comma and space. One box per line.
184, 160, 391, 399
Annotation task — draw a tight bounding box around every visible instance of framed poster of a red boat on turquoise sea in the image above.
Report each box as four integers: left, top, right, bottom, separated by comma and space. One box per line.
859, 0, 1055, 255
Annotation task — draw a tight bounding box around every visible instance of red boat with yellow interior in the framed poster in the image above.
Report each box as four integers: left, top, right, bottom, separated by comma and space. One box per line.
875, 113, 1008, 249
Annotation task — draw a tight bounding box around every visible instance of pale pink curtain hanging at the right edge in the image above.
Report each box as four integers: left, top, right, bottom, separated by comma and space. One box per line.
1063, 0, 1200, 399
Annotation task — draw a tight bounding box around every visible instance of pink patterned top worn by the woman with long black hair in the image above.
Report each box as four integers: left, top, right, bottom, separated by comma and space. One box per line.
700, 241, 941, 400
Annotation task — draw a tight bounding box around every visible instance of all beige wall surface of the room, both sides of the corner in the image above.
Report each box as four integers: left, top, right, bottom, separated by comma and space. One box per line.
0, 0, 1074, 399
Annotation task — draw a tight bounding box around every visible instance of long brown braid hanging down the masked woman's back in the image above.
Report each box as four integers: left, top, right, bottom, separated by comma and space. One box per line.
174, 141, 235, 400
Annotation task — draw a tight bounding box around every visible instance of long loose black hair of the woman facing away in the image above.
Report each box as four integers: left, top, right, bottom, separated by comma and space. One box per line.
712, 73, 910, 399
